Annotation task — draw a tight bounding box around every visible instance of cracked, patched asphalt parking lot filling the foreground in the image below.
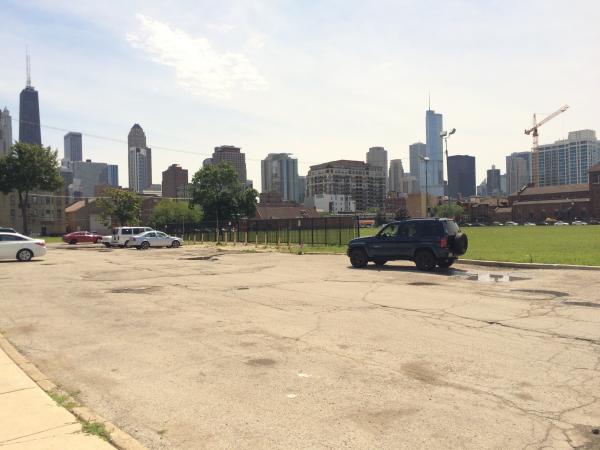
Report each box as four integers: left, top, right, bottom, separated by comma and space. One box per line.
0, 245, 600, 449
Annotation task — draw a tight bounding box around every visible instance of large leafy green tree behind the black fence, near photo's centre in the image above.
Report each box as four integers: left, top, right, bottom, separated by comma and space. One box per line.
192, 163, 258, 229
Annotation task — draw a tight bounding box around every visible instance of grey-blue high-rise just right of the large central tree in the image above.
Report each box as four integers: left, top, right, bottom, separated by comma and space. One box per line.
260, 153, 300, 202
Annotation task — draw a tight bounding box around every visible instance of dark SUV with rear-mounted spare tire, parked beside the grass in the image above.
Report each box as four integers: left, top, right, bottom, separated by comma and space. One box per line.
347, 218, 468, 270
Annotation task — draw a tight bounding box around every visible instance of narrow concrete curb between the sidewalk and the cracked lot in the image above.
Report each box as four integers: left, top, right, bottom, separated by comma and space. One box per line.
0, 333, 147, 450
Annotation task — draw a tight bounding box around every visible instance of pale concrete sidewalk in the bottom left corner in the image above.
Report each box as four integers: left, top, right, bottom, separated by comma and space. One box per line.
0, 336, 114, 450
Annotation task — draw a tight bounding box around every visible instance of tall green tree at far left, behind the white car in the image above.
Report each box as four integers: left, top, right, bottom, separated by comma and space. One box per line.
0, 142, 63, 234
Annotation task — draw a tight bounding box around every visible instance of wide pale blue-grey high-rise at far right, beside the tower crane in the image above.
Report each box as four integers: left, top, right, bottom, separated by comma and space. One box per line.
538, 130, 600, 186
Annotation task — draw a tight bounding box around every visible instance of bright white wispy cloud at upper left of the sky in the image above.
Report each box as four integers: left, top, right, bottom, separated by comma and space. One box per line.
127, 14, 268, 99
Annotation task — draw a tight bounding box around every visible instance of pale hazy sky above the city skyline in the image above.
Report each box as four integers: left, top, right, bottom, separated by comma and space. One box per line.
0, 0, 600, 190
